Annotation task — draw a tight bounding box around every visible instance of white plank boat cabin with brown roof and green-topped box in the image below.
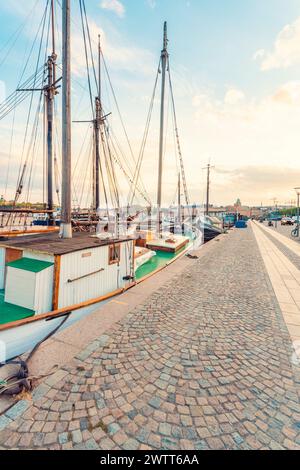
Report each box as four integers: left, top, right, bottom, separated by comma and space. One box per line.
0, 233, 135, 324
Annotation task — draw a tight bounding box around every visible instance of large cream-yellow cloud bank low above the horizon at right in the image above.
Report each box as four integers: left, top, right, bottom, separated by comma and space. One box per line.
186, 81, 300, 204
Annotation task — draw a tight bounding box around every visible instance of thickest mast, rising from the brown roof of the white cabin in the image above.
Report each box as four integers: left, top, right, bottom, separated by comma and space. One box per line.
60, 0, 72, 238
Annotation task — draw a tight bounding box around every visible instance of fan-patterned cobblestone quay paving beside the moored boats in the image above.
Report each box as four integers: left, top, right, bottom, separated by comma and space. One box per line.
0, 227, 300, 450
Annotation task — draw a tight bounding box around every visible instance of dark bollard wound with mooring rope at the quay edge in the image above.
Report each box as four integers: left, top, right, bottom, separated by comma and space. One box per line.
0, 360, 31, 395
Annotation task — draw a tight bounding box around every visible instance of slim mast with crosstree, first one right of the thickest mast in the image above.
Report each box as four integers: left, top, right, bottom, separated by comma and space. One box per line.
94, 35, 102, 210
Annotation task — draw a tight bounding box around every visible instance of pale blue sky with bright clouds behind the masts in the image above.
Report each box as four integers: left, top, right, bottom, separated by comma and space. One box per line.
0, 0, 300, 205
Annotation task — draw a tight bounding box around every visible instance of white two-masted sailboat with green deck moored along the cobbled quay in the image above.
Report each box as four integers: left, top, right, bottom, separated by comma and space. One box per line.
0, 4, 199, 362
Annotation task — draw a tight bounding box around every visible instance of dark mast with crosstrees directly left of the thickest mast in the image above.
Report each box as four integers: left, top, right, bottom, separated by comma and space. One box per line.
46, 0, 57, 225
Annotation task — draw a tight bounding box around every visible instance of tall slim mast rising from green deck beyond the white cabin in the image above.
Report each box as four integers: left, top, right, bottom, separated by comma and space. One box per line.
157, 21, 168, 231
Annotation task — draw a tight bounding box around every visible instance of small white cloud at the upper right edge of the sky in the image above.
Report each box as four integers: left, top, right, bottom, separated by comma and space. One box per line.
254, 18, 300, 71
